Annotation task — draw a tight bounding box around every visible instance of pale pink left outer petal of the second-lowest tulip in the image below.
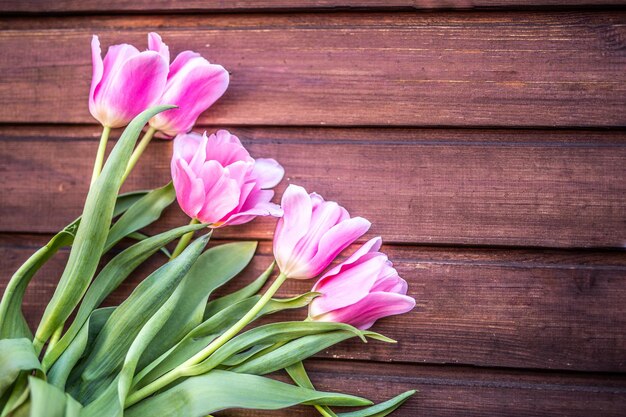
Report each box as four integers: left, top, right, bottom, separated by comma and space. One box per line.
274, 184, 312, 273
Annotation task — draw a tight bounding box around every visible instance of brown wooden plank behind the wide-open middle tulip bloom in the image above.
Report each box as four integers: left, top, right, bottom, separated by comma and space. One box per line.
0, 127, 626, 247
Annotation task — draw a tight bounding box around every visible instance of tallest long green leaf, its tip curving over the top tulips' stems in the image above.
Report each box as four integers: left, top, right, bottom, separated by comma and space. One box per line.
35, 106, 173, 351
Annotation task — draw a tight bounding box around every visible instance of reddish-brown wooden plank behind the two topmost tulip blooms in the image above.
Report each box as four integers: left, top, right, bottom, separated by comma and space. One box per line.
0, 11, 626, 127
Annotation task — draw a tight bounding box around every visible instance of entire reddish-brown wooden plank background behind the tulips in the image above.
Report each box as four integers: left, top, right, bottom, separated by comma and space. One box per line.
0, 0, 626, 417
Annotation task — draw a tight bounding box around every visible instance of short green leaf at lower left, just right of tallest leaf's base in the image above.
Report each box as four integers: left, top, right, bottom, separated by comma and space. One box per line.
47, 307, 115, 390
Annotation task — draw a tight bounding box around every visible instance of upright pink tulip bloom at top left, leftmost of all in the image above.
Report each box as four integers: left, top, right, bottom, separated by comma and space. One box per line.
89, 33, 171, 128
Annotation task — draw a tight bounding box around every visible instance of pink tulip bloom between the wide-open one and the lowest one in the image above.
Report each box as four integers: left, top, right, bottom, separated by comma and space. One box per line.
274, 185, 370, 279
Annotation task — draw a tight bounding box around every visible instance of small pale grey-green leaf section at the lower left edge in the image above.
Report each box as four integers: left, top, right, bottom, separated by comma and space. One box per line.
0, 338, 41, 396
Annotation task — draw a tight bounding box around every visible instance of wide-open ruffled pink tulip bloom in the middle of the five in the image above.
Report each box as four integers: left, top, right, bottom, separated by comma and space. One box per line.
172, 130, 285, 227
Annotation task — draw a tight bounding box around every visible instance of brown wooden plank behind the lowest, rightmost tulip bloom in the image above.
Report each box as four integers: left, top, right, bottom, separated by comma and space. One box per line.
0, 235, 626, 372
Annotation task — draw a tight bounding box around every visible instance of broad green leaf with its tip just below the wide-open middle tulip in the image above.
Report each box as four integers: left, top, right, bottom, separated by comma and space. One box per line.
139, 242, 257, 369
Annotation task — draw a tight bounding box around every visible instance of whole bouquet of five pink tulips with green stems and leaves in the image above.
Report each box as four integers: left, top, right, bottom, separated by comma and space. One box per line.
0, 33, 415, 417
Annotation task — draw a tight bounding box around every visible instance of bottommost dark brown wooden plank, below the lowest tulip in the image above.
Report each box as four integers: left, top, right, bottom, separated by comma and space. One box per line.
227, 360, 626, 417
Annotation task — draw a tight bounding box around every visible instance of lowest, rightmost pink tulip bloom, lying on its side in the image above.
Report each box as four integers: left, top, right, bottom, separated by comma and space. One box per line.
309, 237, 415, 330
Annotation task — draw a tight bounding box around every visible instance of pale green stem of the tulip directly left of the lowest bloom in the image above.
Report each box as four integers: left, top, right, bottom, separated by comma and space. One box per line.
124, 273, 287, 407
